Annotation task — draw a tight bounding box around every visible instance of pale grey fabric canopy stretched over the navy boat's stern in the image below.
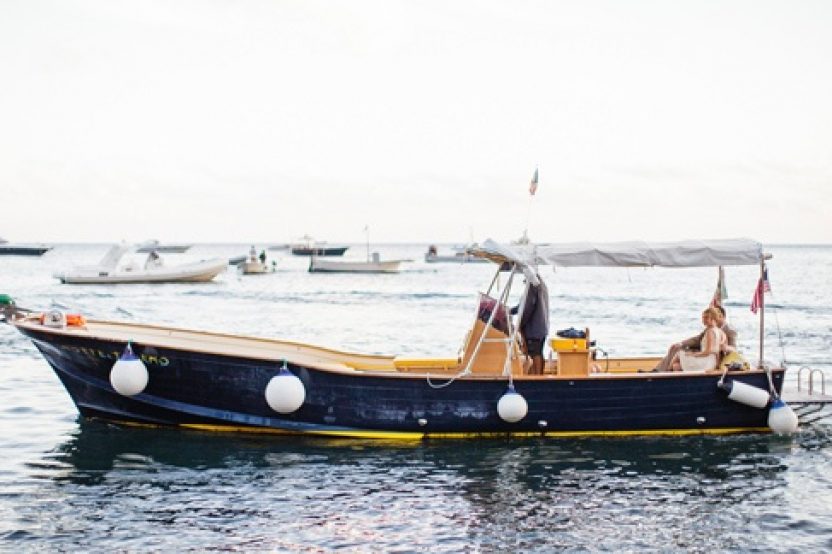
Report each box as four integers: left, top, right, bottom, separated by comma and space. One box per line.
472, 239, 763, 273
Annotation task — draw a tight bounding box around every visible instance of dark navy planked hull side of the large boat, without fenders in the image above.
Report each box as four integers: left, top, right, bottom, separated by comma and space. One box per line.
18, 325, 784, 438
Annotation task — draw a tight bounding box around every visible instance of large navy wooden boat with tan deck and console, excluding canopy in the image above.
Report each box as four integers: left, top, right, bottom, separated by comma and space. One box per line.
1, 239, 785, 439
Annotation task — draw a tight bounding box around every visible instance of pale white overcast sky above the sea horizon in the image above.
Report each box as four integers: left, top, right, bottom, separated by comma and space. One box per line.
0, 0, 832, 243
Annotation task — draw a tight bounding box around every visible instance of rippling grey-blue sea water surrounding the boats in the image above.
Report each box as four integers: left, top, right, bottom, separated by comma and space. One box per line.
0, 245, 832, 552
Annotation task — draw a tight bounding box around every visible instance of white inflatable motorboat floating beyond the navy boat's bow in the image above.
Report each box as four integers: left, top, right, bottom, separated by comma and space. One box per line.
54, 244, 227, 285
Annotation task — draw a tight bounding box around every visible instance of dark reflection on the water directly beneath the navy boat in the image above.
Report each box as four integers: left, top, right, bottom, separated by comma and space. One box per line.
45, 417, 788, 472
